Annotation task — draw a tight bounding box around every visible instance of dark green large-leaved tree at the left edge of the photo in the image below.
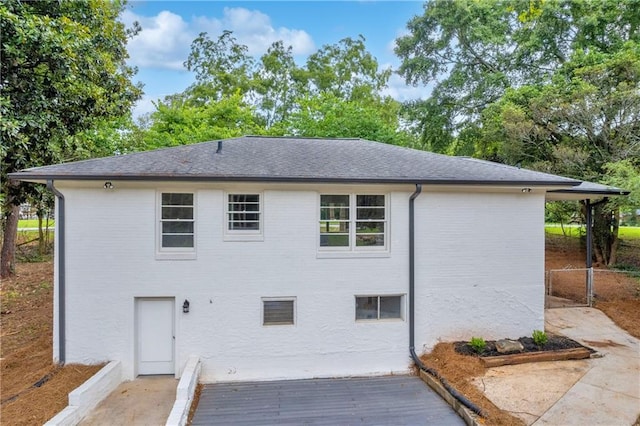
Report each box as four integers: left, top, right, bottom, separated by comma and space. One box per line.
0, 0, 141, 277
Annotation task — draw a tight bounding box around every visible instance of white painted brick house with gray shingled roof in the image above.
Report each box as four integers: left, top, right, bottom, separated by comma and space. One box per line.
11, 137, 620, 381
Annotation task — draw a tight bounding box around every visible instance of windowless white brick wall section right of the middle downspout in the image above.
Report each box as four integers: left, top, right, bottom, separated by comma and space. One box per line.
416, 193, 544, 349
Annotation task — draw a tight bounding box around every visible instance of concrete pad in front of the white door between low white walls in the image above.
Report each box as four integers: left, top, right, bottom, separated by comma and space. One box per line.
79, 376, 178, 426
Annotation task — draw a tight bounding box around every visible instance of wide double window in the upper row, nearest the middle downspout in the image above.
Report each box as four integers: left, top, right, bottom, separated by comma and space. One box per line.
320, 194, 388, 251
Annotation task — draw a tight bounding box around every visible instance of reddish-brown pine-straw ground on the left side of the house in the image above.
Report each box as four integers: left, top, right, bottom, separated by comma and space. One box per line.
0, 261, 100, 425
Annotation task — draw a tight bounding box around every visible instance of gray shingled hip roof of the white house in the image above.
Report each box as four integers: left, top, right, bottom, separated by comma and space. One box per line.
10, 136, 580, 187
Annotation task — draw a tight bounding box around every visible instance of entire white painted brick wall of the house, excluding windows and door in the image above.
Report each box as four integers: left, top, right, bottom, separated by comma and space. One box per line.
57, 182, 544, 381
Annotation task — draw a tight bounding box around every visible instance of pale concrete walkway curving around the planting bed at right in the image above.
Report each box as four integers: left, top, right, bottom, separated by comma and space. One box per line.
476, 308, 640, 426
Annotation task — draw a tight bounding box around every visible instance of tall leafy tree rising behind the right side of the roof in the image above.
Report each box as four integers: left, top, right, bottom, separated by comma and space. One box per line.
395, 0, 640, 152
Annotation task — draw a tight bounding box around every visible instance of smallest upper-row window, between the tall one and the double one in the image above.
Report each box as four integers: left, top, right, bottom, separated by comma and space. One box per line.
225, 193, 262, 240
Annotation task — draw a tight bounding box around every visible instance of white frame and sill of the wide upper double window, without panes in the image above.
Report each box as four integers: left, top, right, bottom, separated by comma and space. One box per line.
316, 191, 391, 253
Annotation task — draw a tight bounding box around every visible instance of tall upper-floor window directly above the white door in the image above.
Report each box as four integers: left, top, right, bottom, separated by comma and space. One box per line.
160, 192, 195, 251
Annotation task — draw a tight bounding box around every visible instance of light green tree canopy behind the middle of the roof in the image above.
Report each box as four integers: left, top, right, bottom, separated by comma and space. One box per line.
145, 31, 412, 147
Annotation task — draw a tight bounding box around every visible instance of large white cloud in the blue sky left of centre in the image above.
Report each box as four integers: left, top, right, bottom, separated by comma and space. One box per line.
120, 7, 315, 70
